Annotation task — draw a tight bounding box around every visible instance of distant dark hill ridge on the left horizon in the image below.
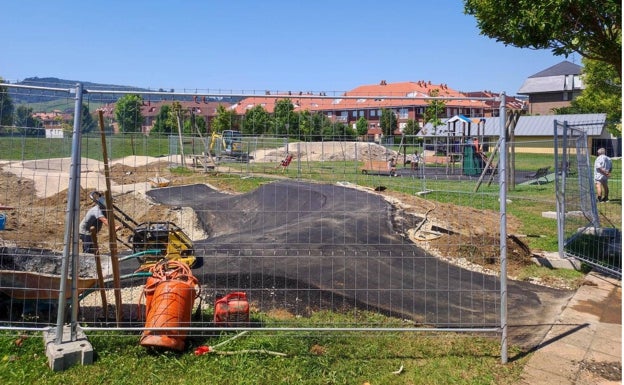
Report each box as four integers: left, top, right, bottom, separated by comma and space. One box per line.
9, 77, 240, 104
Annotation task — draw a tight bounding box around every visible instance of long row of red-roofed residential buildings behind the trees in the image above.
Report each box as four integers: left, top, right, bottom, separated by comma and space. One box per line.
104, 80, 526, 139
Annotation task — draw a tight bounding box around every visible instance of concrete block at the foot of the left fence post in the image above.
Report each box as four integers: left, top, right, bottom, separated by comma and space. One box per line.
43, 325, 93, 372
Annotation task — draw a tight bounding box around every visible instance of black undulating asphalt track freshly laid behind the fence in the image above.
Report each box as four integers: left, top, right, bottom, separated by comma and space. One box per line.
147, 180, 572, 346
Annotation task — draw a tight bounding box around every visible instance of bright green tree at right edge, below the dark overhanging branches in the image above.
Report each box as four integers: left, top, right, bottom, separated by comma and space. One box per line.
554, 58, 622, 137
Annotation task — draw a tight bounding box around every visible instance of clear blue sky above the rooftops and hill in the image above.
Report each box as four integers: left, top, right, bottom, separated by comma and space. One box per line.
0, 0, 580, 95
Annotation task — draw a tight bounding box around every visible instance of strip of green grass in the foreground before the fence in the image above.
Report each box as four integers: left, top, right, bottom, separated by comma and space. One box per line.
0, 313, 526, 385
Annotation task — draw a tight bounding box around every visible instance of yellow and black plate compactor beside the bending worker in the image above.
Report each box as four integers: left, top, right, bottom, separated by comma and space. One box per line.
89, 191, 202, 269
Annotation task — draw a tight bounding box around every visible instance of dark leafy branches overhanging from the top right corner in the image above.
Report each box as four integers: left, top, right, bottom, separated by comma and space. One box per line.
464, 0, 622, 80
